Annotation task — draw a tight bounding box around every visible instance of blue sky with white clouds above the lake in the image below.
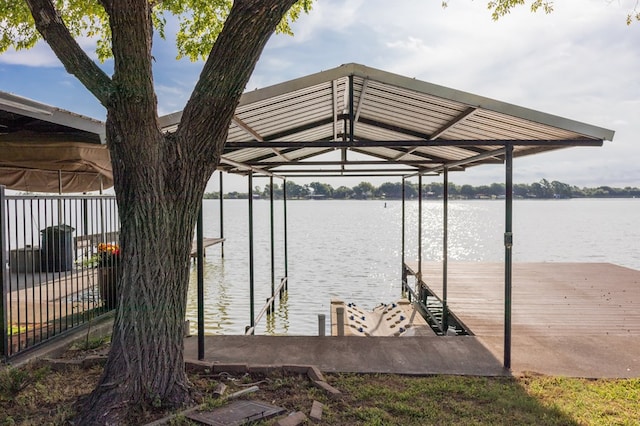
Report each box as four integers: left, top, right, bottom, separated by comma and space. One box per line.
0, 0, 640, 192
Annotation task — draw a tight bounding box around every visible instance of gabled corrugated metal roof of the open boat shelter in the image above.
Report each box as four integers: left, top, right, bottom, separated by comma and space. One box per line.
161, 64, 614, 174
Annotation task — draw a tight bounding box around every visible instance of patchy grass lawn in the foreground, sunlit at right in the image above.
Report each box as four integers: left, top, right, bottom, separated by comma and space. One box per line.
0, 352, 640, 425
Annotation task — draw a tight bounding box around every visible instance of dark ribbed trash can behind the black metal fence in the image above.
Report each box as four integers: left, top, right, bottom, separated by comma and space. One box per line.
40, 225, 75, 272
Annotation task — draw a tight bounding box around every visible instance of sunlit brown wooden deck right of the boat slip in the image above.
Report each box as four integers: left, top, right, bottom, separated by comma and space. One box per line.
409, 262, 640, 377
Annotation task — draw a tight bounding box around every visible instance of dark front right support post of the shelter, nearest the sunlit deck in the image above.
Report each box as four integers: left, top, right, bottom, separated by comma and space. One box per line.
504, 145, 513, 369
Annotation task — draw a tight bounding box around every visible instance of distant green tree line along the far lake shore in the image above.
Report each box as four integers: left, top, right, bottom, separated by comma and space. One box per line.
204, 179, 640, 200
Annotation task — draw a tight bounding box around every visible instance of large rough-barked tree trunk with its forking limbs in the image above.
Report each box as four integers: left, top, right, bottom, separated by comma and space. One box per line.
18, 0, 295, 425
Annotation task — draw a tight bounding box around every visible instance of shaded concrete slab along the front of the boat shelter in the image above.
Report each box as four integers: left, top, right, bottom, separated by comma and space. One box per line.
185, 336, 509, 376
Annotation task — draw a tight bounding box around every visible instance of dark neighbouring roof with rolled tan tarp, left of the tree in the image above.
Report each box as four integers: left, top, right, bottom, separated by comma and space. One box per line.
0, 92, 113, 193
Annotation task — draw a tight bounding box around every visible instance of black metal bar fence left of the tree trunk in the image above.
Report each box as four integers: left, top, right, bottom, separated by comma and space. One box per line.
0, 186, 120, 359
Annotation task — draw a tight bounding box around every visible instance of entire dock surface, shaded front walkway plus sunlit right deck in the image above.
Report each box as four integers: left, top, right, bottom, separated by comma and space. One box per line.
179, 263, 640, 378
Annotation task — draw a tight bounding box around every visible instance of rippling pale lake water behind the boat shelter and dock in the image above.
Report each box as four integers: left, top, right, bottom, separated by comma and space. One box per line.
182, 199, 640, 335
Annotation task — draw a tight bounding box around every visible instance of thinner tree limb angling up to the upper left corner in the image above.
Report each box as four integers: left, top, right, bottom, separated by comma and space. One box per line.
26, 0, 111, 107
